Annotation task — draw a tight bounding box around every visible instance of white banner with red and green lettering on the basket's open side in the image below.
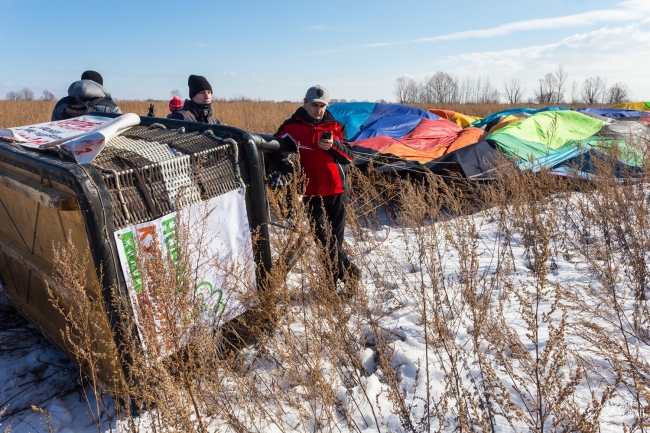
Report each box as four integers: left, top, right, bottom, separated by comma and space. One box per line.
115, 189, 257, 358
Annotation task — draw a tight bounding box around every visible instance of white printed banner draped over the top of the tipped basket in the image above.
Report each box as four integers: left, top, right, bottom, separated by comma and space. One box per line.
0, 113, 140, 164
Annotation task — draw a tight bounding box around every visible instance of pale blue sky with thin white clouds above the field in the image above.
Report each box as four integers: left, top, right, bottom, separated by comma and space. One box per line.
0, 0, 650, 101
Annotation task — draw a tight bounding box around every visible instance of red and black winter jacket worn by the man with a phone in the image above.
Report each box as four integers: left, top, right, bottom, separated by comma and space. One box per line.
275, 107, 354, 197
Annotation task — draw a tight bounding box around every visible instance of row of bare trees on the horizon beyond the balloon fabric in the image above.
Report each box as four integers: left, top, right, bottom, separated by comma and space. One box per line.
393, 66, 632, 105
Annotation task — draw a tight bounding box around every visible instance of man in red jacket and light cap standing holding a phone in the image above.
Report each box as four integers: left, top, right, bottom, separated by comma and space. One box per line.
275, 85, 361, 294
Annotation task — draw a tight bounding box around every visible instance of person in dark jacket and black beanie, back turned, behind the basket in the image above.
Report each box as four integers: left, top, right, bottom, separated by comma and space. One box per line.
51, 71, 122, 122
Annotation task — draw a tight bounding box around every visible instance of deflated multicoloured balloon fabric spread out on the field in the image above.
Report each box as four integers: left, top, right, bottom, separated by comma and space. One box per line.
328, 102, 650, 179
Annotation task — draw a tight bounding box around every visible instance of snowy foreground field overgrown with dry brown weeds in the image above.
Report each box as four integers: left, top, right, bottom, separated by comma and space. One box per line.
2, 157, 650, 432
